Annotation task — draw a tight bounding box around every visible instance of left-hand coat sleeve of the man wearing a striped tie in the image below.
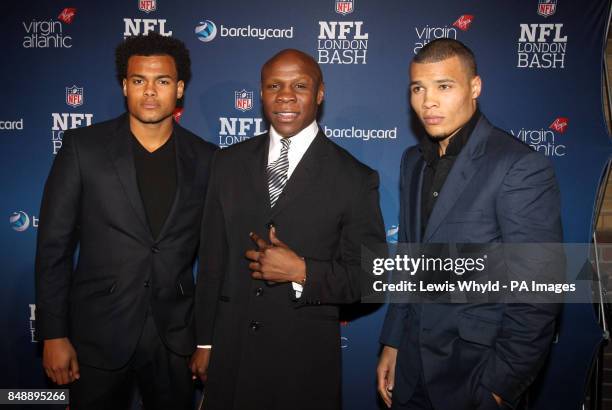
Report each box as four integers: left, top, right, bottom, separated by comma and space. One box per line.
195, 151, 228, 345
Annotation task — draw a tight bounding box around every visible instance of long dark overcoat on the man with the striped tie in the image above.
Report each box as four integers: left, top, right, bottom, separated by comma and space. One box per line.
196, 132, 385, 410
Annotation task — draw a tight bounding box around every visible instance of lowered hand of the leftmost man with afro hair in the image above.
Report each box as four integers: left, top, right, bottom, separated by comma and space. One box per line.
43, 337, 81, 384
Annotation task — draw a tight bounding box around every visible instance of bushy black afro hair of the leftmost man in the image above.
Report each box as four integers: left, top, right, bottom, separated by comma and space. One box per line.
115, 32, 191, 85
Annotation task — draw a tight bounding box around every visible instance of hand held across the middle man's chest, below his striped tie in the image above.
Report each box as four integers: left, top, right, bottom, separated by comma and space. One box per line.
245, 227, 306, 283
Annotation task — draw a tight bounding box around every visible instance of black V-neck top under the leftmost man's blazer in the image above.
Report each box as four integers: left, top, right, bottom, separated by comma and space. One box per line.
133, 135, 176, 238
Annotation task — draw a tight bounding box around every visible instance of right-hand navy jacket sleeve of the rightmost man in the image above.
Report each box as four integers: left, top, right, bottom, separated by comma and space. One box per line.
481, 152, 564, 404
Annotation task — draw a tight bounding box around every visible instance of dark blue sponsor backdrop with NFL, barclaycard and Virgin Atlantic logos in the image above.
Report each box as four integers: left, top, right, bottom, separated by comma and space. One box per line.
0, 0, 612, 409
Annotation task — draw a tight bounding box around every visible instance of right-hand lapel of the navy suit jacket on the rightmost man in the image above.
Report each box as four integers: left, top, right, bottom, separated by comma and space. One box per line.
423, 116, 492, 242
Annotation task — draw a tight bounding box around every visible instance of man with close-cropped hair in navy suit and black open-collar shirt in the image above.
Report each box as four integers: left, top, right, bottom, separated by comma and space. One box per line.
377, 39, 564, 410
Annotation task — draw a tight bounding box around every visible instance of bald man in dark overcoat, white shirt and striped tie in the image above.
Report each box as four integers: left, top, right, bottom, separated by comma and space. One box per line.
192, 50, 385, 410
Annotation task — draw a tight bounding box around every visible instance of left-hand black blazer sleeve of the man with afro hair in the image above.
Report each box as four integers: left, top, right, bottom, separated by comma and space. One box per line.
35, 131, 81, 340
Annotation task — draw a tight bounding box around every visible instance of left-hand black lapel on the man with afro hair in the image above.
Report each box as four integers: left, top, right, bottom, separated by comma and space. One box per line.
108, 115, 151, 237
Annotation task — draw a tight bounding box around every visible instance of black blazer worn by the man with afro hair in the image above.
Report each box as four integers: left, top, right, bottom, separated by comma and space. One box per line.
36, 114, 215, 369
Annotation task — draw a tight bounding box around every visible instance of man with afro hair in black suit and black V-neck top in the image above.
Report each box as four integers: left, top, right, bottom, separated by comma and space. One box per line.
36, 33, 215, 410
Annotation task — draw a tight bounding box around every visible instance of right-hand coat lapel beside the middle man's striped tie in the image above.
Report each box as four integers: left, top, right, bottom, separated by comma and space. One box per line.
266, 130, 328, 217
